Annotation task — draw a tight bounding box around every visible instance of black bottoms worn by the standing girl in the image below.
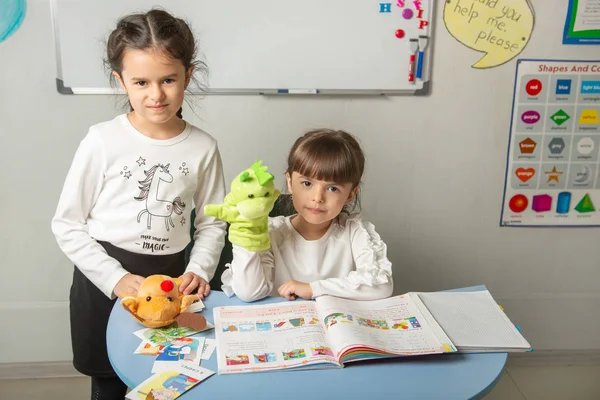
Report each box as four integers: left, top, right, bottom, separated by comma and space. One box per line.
69, 242, 185, 386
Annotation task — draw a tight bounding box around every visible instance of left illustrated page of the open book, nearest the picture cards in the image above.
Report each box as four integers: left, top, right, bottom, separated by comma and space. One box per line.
213, 301, 339, 374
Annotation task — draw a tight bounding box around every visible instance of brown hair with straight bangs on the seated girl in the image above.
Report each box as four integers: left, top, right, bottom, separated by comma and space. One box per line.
286, 129, 365, 212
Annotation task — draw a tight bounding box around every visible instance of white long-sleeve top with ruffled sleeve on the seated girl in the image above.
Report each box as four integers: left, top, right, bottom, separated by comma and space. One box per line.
221, 214, 393, 301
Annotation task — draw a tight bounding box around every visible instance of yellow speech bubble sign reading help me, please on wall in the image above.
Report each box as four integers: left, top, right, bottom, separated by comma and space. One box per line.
444, 0, 535, 68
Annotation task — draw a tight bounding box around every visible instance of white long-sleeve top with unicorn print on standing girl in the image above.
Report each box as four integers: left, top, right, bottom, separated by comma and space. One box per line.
52, 114, 226, 298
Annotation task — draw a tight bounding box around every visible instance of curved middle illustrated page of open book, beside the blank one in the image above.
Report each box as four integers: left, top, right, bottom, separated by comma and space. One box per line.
316, 295, 454, 362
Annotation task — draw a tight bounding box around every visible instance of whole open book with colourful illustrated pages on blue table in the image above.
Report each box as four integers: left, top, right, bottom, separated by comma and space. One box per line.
213, 291, 530, 374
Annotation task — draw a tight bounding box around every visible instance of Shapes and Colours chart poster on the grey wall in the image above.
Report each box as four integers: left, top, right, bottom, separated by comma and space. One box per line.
500, 59, 600, 226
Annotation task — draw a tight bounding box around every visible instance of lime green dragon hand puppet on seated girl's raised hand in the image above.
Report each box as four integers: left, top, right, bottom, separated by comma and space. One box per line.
204, 161, 280, 251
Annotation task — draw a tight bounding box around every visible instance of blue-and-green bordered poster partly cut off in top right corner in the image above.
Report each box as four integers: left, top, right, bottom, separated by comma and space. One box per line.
563, 0, 600, 44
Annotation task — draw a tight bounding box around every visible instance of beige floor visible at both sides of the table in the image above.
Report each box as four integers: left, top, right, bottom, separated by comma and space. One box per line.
0, 362, 600, 400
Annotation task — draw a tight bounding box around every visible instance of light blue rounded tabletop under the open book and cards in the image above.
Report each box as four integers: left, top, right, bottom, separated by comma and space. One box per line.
106, 287, 507, 400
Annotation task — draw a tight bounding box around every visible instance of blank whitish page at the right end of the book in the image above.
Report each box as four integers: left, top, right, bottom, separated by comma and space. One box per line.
418, 290, 529, 351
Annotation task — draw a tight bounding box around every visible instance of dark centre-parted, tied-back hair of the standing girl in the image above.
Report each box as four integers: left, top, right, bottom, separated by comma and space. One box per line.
104, 9, 208, 118
